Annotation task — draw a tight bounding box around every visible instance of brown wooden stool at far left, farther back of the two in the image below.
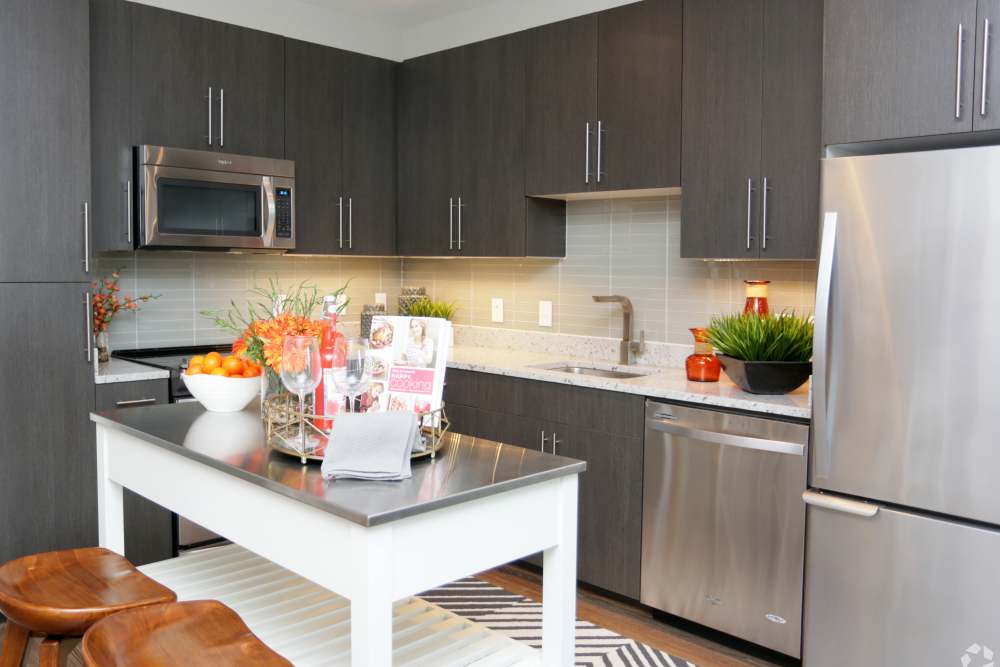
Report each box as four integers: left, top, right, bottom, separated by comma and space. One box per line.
0, 548, 177, 667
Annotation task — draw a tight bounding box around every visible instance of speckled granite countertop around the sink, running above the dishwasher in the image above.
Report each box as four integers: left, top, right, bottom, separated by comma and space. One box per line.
448, 345, 811, 419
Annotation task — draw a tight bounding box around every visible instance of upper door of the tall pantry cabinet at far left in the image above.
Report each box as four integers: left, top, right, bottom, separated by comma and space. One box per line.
0, 0, 90, 282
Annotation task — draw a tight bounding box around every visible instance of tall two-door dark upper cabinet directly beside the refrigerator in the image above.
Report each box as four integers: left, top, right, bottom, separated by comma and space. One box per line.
681, 0, 823, 259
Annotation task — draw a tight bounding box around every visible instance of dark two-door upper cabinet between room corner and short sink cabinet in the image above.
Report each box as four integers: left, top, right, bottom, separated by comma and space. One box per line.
397, 33, 565, 257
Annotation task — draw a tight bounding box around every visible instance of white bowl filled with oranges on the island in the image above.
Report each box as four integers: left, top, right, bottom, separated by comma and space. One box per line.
181, 352, 261, 412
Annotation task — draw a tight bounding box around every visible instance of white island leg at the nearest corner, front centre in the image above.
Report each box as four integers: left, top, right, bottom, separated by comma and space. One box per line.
351, 526, 393, 667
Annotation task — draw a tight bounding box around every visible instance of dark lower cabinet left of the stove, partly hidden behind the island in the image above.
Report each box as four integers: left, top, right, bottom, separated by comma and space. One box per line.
95, 379, 175, 565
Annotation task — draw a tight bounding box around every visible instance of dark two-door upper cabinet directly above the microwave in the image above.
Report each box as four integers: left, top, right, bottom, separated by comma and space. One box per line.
131, 4, 285, 157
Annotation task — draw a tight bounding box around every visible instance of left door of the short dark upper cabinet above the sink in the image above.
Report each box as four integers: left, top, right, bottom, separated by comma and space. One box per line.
525, 14, 597, 195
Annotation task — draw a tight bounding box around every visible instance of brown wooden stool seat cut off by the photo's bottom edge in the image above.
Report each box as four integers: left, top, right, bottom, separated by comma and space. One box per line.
81, 600, 292, 667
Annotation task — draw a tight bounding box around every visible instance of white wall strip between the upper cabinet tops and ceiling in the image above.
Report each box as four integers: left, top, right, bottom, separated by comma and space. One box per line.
132, 0, 636, 60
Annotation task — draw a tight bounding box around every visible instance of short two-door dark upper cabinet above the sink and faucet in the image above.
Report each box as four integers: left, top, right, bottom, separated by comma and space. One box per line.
525, 0, 683, 195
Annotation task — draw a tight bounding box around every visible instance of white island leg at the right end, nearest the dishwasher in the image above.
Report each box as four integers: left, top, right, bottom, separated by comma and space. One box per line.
542, 475, 578, 667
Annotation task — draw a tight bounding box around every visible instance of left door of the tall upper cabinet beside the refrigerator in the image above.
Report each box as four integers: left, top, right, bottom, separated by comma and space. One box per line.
681, 0, 764, 259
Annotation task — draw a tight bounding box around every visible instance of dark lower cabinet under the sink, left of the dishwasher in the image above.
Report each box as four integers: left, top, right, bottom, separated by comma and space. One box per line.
445, 369, 645, 599
